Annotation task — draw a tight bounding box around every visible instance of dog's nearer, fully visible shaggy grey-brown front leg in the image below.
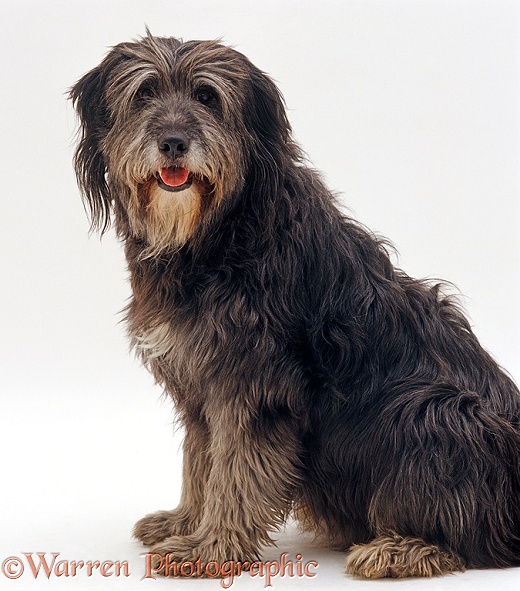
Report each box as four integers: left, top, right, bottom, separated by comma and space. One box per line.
150, 403, 300, 575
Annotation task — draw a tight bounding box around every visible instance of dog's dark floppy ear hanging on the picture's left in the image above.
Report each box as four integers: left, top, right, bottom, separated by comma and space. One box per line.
69, 60, 111, 234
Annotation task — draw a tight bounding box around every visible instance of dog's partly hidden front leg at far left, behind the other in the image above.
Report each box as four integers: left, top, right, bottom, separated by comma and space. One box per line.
133, 421, 209, 546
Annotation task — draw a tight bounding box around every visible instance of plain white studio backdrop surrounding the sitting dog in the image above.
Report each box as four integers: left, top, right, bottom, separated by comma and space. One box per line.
0, 0, 520, 591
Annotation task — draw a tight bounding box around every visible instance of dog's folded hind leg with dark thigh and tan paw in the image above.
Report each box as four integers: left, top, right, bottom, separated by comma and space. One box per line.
346, 383, 520, 578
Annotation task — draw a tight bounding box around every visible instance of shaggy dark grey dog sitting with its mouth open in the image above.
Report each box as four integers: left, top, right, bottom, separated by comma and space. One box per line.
70, 31, 520, 578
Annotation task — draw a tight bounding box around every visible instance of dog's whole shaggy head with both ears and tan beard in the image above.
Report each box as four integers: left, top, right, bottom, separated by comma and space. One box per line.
71, 35, 289, 256
